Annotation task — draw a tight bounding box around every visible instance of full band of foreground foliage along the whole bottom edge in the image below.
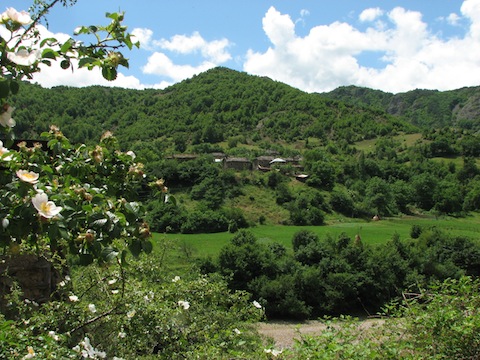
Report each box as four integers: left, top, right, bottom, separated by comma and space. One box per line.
0, 255, 480, 359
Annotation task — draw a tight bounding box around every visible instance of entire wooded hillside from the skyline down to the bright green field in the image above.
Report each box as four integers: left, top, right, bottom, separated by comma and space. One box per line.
7, 68, 480, 233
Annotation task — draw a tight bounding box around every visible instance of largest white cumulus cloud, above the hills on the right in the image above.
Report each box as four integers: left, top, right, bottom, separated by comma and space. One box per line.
243, 0, 480, 92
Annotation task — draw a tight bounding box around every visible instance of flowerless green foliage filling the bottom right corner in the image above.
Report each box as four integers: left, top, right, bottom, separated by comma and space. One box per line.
284, 277, 480, 359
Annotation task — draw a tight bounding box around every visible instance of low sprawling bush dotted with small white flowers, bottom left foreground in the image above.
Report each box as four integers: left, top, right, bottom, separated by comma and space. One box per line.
0, 249, 265, 359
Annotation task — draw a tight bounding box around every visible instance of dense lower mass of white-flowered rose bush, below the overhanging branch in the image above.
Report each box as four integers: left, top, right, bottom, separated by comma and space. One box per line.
0, 127, 164, 263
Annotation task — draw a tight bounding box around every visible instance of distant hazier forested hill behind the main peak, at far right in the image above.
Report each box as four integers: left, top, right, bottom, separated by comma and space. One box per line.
322, 86, 480, 130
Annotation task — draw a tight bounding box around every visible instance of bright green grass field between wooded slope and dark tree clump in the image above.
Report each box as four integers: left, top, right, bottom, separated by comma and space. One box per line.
154, 214, 480, 257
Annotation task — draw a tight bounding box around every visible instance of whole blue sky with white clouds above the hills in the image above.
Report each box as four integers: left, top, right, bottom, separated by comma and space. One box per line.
6, 0, 480, 93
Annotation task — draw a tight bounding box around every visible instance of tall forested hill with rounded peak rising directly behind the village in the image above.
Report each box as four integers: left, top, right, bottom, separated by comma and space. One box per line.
14, 68, 414, 150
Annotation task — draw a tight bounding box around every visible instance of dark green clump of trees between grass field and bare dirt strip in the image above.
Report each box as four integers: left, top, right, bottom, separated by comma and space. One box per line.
201, 226, 480, 319
